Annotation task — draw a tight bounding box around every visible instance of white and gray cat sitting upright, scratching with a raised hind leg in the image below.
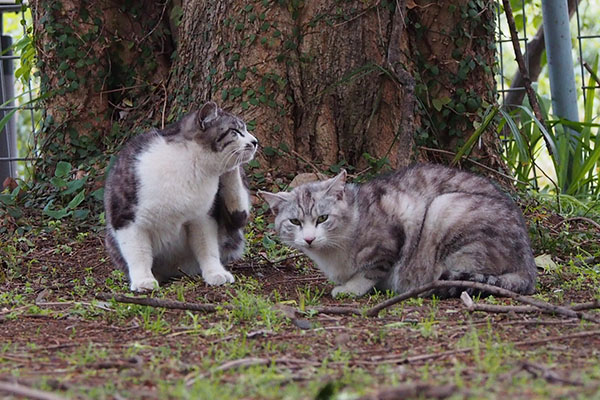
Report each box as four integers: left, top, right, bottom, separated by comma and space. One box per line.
104, 102, 258, 291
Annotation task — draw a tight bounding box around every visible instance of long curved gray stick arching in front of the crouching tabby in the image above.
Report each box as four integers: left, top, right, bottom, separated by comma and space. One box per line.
366, 281, 600, 324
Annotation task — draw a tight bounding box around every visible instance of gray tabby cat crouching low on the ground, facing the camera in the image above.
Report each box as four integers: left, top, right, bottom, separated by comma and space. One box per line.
259, 164, 536, 296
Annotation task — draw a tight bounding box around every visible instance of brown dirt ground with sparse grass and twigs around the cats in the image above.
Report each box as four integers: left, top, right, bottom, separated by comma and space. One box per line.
0, 214, 600, 399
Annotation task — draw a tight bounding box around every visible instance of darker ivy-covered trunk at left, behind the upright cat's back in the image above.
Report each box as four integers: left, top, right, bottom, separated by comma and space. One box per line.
31, 0, 173, 176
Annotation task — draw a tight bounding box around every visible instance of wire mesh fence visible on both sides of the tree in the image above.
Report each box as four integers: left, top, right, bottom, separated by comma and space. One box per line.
0, 0, 600, 183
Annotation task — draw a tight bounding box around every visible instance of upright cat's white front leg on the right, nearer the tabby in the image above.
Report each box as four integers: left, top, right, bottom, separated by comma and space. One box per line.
189, 216, 235, 285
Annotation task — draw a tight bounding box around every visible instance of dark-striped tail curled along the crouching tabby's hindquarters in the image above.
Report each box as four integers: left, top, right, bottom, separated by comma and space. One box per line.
434, 271, 536, 298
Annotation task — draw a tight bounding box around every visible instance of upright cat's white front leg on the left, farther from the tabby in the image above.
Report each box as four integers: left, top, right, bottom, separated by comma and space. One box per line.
115, 224, 158, 292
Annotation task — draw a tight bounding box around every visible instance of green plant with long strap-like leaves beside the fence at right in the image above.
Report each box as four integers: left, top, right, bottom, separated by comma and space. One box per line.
454, 56, 600, 199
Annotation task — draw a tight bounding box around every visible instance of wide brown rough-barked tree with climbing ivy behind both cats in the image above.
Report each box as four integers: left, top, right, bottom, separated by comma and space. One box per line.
33, 0, 497, 172
